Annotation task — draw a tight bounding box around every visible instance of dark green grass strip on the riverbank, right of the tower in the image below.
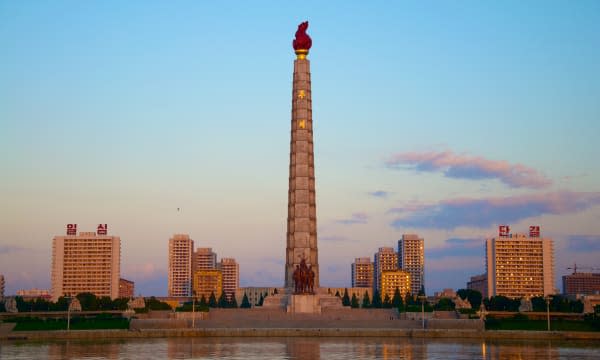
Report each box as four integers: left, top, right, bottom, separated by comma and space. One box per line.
485, 319, 598, 331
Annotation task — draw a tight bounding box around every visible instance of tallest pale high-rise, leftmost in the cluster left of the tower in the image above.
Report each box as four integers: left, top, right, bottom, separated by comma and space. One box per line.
168, 234, 194, 296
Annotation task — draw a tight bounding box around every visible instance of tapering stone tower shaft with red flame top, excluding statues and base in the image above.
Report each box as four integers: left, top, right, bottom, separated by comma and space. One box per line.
285, 22, 319, 289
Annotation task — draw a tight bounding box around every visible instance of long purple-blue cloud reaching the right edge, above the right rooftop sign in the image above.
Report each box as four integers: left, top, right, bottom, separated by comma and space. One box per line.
388, 191, 600, 229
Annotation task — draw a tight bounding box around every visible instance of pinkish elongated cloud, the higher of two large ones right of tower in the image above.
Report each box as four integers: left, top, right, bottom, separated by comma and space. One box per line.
385, 151, 552, 189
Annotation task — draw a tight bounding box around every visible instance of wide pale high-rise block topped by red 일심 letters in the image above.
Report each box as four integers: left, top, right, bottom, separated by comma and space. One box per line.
51, 228, 121, 301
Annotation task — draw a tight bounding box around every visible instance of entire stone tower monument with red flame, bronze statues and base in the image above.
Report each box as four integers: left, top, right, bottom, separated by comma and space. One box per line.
263, 22, 343, 314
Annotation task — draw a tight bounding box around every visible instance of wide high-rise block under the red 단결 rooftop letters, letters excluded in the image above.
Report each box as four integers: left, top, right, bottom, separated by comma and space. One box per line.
486, 234, 555, 298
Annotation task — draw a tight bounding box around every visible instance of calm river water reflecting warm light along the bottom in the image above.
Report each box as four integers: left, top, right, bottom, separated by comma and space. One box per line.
0, 337, 600, 360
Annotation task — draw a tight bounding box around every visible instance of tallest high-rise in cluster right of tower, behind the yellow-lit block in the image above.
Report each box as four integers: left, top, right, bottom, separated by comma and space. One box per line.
398, 234, 425, 295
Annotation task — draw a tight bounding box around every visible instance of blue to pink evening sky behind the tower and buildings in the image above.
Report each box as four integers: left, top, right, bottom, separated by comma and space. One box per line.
0, 0, 600, 295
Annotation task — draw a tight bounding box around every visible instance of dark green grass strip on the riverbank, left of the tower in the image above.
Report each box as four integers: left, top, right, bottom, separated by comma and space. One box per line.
6, 316, 129, 331
